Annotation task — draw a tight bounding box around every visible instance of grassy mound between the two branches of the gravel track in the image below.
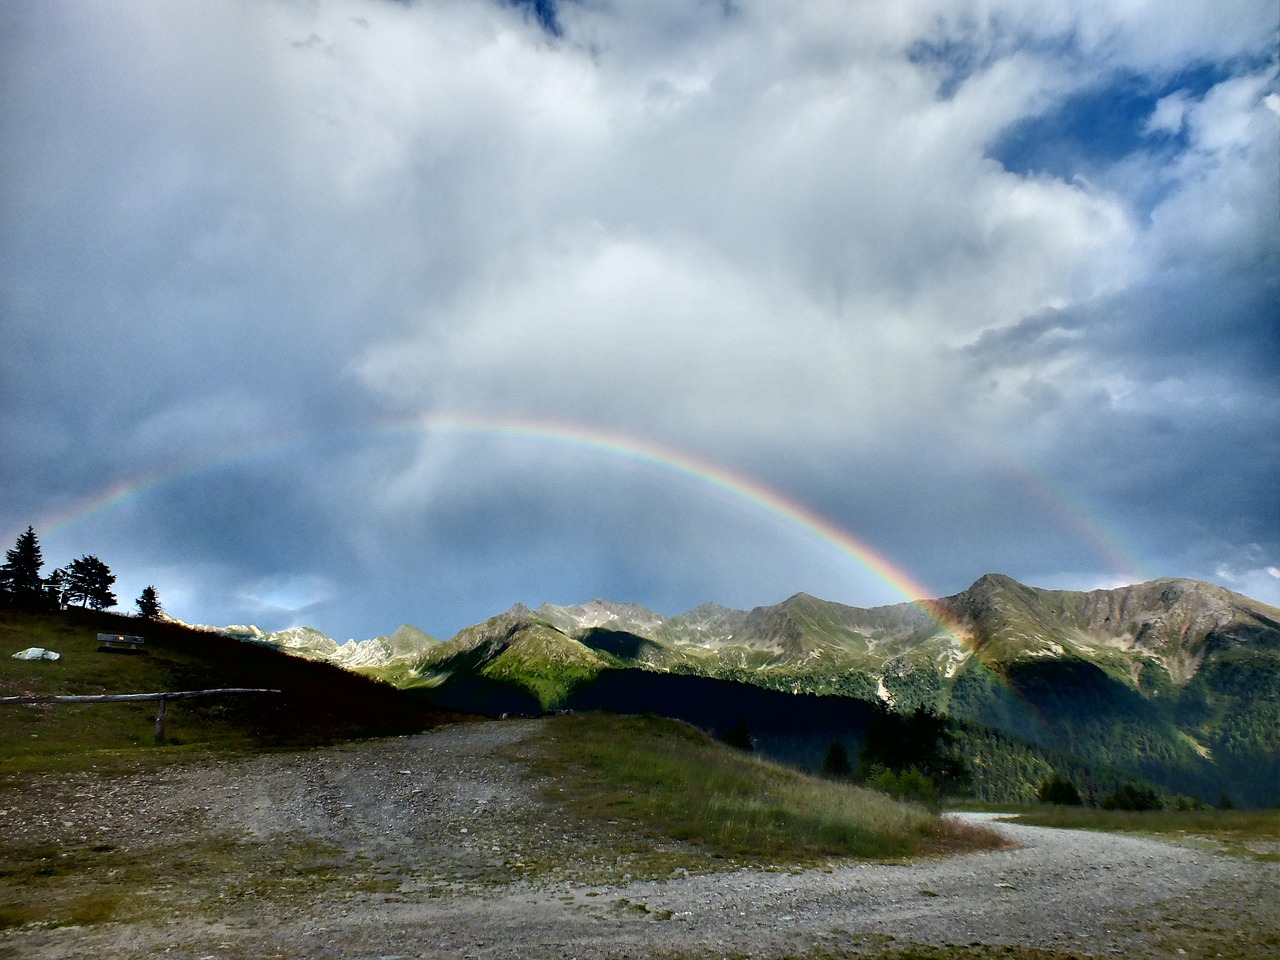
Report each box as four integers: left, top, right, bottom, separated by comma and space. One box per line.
543, 714, 1001, 867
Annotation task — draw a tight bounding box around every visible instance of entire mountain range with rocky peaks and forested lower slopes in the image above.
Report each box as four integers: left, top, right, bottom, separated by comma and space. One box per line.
225, 575, 1280, 804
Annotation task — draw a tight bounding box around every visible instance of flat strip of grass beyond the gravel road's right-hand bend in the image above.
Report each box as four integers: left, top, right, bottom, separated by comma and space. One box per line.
1016, 804, 1280, 860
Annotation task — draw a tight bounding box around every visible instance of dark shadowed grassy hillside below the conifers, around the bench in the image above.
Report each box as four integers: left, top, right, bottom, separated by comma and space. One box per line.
0, 609, 454, 769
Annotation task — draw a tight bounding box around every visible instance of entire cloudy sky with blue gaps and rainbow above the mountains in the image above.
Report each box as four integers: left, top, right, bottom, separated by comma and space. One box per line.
0, 0, 1280, 641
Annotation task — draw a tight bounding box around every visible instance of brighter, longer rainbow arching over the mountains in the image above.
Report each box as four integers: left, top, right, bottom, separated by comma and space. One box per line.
30, 413, 963, 640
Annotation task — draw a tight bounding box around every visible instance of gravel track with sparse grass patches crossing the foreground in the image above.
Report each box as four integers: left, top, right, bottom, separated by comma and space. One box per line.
0, 721, 1280, 960
